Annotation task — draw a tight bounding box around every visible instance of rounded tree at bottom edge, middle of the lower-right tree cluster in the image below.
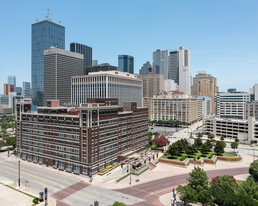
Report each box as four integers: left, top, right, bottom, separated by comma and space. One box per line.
211, 175, 237, 206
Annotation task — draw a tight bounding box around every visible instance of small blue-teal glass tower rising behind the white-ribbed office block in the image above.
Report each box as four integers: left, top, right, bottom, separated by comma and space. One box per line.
118, 55, 134, 74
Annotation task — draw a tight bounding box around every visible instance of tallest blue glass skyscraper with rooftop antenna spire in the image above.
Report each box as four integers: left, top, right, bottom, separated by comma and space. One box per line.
31, 13, 65, 106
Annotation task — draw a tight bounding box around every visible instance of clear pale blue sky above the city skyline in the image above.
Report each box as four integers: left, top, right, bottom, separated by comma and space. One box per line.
0, 0, 258, 93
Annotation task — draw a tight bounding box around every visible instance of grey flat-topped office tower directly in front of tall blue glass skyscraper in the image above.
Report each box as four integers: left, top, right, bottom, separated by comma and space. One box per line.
44, 47, 84, 105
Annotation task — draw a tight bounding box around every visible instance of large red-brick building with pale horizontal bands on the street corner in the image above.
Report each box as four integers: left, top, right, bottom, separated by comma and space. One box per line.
16, 101, 148, 175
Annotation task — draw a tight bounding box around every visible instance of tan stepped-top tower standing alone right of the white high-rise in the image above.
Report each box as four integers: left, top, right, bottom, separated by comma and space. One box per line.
192, 71, 219, 114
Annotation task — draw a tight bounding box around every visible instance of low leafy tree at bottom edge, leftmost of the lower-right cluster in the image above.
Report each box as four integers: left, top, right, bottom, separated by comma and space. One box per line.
176, 185, 198, 204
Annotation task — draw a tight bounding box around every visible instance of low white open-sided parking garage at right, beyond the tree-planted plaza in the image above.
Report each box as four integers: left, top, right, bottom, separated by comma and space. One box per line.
204, 117, 258, 143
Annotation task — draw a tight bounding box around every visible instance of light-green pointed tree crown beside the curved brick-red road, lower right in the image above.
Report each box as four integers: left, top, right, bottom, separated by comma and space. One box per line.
187, 167, 208, 194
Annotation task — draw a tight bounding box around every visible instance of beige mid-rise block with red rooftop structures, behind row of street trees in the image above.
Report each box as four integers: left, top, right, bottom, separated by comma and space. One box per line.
145, 92, 198, 124
